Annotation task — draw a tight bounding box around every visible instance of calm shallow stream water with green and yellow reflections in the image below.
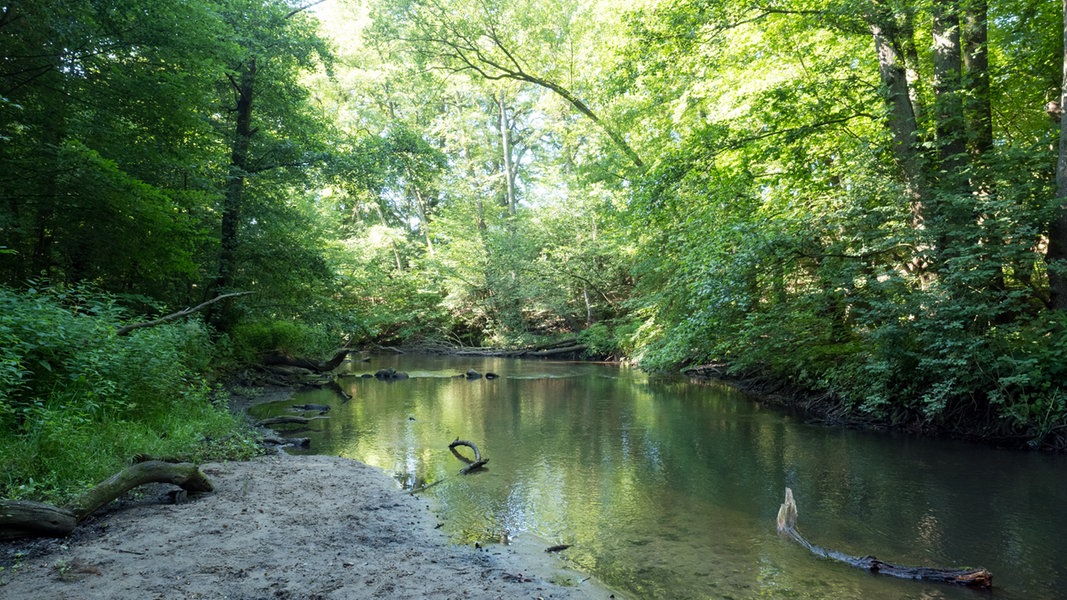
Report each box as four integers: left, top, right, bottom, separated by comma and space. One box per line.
249, 356, 1067, 599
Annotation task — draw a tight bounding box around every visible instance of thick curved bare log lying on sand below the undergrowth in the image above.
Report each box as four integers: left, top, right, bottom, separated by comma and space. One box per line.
0, 460, 213, 540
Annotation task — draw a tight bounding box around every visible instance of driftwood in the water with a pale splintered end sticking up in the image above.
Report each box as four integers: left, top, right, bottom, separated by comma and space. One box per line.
778, 488, 993, 589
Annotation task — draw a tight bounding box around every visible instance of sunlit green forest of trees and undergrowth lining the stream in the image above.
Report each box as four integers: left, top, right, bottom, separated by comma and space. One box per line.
0, 0, 1067, 498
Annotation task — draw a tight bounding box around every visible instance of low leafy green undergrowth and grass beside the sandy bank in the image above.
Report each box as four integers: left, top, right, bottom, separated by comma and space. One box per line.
0, 288, 259, 503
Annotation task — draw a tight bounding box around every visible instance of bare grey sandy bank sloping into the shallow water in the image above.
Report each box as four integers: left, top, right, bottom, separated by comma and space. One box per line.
0, 384, 614, 600
